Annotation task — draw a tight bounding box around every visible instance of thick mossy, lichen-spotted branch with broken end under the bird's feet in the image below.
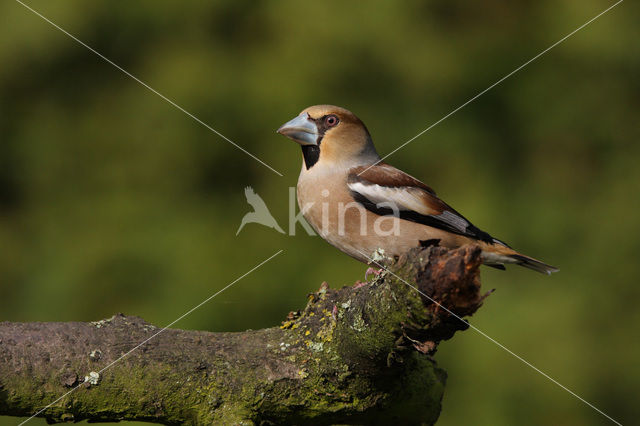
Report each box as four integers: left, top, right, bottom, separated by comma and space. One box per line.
0, 247, 485, 425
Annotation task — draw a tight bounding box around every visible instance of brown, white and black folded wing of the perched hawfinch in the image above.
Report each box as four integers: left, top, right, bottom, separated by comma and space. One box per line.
347, 163, 506, 245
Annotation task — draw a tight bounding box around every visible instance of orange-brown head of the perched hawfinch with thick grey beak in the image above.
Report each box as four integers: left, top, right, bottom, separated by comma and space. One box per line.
278, 105, 380, 169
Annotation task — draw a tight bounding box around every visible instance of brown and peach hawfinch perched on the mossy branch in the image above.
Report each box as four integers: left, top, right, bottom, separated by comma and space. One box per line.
277, 105, 558, 274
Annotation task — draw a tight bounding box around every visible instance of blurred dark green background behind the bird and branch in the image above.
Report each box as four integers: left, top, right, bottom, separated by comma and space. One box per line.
0, 0, 640, 425
